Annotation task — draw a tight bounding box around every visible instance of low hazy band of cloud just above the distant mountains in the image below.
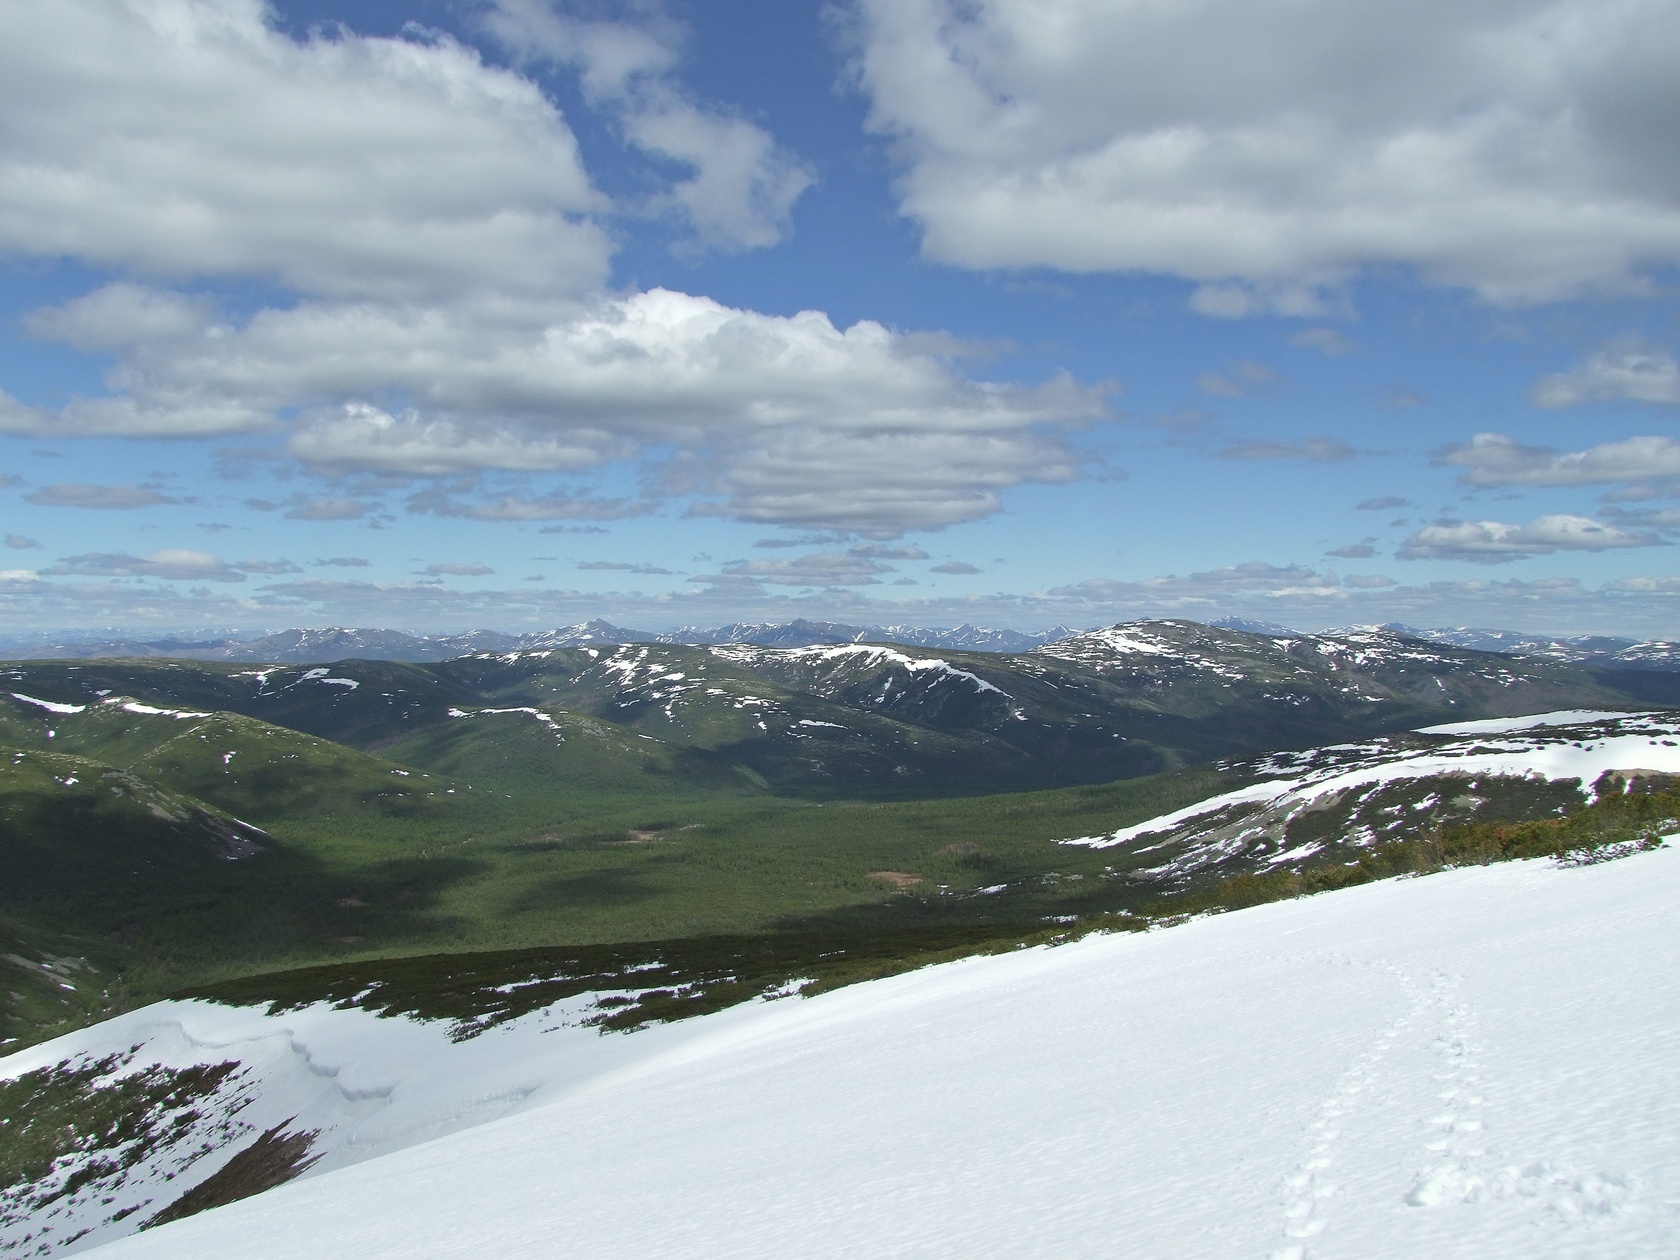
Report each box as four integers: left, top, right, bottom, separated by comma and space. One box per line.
0, 561, 1680, 638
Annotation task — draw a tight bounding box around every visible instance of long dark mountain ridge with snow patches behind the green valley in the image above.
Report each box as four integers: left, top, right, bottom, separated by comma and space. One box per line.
0, 622, 1653, 796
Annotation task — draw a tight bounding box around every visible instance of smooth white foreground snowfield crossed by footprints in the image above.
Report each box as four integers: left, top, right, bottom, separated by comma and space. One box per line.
59, 848, 1680, 1260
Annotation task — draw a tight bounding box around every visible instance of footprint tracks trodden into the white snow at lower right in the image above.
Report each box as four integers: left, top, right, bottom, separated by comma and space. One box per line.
1270, 968, 1638, 1260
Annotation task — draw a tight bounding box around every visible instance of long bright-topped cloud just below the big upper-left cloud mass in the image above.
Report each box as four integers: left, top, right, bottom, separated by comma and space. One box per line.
22, 289, 1107, 536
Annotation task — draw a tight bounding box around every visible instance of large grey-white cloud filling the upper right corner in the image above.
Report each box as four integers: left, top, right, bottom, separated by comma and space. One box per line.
853, 0, 1680, 305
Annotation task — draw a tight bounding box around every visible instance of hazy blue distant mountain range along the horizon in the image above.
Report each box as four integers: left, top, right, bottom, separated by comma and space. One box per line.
0, 617, 1680, 670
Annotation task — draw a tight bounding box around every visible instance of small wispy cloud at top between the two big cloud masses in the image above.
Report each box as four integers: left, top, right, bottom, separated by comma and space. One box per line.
484, 0, 813, 250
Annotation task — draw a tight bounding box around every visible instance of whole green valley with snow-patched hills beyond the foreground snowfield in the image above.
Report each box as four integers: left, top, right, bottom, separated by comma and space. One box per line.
0, 622, 1680, 1255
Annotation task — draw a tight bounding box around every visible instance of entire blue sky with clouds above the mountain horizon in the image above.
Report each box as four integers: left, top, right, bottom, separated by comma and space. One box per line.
0, 0, 1680, 638
